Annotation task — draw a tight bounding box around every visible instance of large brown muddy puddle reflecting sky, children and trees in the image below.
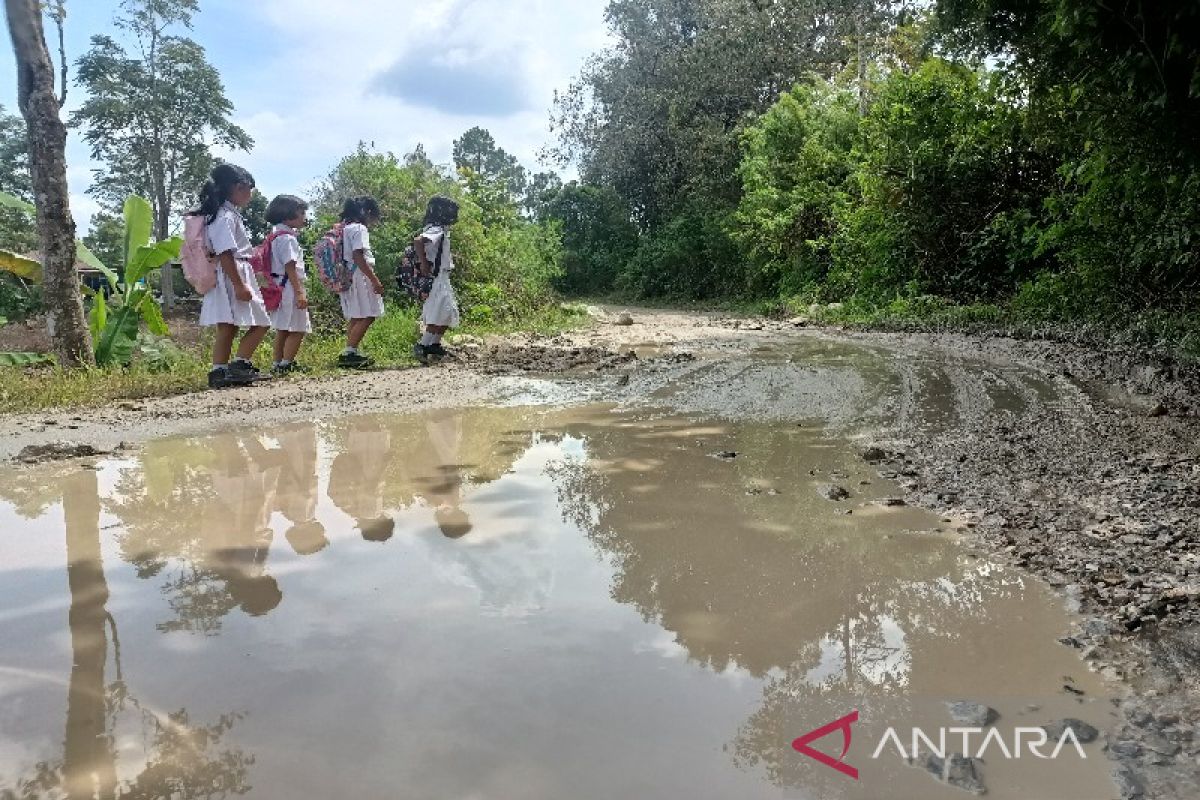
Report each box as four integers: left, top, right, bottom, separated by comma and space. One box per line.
0, 408, 1112, 800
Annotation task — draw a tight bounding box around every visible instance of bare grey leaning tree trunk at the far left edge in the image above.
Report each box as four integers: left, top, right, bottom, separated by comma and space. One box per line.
5, 0, 95, 367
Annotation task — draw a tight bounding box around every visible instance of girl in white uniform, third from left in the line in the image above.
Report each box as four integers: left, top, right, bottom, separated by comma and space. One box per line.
337, 197, 383, 369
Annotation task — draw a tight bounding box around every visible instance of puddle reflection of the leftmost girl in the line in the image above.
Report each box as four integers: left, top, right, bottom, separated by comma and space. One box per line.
203, 437, 283, 616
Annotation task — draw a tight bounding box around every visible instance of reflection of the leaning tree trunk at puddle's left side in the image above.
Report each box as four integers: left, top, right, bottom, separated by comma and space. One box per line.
0, 470, 254, 800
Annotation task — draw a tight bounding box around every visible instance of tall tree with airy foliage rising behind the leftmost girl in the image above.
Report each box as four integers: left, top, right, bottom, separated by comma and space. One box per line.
72, 0, 253, 306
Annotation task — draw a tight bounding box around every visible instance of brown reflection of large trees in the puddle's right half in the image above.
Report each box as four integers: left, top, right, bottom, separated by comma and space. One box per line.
544, 420, 1014, 788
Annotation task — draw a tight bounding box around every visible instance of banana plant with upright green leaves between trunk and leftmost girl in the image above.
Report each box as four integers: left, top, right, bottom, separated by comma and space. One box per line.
89, 196, 184, 367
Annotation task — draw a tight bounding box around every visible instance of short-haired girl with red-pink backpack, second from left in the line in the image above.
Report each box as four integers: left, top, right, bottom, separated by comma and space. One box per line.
266, 194, 312, 374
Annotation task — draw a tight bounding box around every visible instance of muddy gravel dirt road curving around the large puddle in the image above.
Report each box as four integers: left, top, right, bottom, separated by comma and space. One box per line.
7, 308, 1200, 798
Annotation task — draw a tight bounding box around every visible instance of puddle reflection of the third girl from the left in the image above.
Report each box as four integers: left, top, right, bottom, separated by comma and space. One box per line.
329, 417, 396, 542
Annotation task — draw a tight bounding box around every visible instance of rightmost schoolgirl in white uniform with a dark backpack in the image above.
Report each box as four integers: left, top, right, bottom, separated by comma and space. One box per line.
413, 197, 461, 363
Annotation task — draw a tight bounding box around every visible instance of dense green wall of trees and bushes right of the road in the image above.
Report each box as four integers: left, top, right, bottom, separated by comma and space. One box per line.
551, 0, 1200, 345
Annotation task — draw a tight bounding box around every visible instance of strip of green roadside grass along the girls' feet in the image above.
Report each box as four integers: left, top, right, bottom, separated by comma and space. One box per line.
0, 306, 588, 414
